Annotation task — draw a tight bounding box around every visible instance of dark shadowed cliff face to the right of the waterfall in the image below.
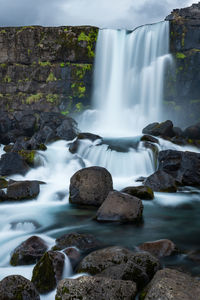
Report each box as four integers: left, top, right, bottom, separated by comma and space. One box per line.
164, 3, 200, 126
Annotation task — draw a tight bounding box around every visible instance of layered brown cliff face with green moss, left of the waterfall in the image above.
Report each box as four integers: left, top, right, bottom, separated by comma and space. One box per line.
0, 26, 98, 114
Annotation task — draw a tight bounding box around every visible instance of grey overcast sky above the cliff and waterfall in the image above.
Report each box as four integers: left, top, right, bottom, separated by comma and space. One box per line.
0, 0, 198, 28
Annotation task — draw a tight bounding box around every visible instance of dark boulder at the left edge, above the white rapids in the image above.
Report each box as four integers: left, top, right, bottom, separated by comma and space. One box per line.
0, 152, 29, 176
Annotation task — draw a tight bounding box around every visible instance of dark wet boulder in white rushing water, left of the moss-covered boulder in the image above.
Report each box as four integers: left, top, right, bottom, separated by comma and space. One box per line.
10, 236, 48, 266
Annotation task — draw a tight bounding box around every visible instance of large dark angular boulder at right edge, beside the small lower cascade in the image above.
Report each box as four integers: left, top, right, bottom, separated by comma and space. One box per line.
158, 150, 200, 186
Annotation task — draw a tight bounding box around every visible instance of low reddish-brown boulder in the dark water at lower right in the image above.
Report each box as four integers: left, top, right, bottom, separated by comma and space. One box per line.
138, 239, 176, 257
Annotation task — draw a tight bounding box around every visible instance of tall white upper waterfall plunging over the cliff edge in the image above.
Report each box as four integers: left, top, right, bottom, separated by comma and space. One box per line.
79, 22, 171, 136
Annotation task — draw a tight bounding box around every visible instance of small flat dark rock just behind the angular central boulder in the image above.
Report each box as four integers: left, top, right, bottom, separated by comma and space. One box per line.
121, 186, 154, 200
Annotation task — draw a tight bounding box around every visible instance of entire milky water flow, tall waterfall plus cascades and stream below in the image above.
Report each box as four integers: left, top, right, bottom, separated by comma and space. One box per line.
0, 22, 200, 300
